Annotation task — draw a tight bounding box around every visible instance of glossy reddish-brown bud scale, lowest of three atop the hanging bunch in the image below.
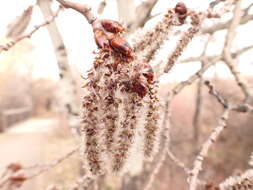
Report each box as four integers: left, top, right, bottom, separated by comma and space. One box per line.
110, 37, 133, 57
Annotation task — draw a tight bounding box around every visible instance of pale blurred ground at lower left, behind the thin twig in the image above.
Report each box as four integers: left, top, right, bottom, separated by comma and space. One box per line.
0, 118, 80, 190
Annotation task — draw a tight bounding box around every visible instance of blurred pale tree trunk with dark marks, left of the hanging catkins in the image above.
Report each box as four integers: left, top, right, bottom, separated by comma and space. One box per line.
37, 0, 79, 126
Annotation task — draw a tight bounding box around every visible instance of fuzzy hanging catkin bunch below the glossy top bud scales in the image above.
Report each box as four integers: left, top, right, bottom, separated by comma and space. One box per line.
81, 49, 159, 175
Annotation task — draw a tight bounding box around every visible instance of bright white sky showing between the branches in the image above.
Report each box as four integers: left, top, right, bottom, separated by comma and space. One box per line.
0, 0, 253, 82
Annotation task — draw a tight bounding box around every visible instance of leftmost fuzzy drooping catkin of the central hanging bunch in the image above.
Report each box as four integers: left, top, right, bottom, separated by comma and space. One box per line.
81, 51, 113, 175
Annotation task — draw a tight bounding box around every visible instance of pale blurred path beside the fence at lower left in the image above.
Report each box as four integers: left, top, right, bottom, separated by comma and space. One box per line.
0, 118, 57, 190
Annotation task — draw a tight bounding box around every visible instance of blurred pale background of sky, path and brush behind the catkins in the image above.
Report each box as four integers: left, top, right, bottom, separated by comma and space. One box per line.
0, 0, 253, 190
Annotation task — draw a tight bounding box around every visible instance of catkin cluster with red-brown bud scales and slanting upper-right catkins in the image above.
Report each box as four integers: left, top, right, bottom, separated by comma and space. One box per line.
81, 3, 201, 175
